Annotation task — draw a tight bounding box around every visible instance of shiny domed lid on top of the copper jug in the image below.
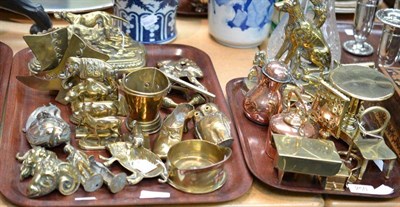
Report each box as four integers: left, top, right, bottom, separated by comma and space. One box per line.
262, 60, 290, 83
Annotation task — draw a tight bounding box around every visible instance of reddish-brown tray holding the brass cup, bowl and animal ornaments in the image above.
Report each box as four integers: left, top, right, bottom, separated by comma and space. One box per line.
0, 45, 253, 206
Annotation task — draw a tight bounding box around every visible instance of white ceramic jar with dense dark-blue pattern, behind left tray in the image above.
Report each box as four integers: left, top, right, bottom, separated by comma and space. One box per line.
114, 0, 178, 44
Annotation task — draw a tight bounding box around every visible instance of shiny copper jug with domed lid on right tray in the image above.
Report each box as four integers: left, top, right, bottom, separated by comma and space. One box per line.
243, 60, 291, 125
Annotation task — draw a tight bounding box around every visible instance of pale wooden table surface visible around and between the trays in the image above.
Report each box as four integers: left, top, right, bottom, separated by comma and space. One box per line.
0, 5, 400, 206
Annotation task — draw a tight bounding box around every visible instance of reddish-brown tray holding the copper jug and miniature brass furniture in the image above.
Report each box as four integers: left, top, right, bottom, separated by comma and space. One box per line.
226, 78, 400, 198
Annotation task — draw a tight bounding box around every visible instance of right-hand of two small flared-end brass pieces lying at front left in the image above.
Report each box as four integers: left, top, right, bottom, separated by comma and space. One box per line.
89, 155, 127, 193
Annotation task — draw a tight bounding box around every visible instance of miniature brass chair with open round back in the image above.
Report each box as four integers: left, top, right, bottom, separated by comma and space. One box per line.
349, 106, 397, 180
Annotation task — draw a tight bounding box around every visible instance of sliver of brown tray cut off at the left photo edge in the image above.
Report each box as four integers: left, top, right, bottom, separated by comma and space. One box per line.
0, 42, 13, 123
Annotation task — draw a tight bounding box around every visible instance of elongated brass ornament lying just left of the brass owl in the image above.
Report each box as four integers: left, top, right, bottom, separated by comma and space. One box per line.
153, 103, 194, 159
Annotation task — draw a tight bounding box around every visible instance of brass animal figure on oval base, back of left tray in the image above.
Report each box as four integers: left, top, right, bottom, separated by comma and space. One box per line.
54, 11, 146, 72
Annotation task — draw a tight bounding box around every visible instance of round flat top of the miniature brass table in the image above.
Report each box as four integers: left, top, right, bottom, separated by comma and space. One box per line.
329, 65, 394, 101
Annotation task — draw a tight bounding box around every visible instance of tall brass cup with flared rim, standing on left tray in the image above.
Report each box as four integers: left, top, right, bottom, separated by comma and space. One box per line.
121, 67, 171, 133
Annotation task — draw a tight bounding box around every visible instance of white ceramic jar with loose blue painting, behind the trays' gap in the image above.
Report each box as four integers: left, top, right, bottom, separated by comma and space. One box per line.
208, 0, 275, 48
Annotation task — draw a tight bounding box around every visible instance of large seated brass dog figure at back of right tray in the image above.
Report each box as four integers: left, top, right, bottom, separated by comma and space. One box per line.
275, 0, 331, 78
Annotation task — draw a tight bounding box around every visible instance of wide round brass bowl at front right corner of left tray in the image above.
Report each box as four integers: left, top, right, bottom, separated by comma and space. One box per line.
166, 139, 232, 194
